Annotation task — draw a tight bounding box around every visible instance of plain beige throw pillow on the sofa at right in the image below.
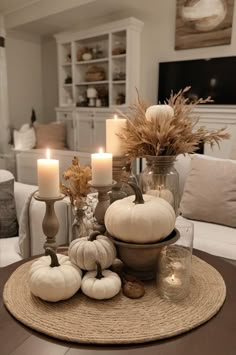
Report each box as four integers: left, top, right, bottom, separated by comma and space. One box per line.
180, 154, 236, 227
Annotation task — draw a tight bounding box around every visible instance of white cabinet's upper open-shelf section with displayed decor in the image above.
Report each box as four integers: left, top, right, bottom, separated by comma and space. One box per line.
55, 17, 143, 108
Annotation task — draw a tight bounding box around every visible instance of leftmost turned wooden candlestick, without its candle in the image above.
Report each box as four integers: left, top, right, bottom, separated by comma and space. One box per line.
34, 192, 65, 252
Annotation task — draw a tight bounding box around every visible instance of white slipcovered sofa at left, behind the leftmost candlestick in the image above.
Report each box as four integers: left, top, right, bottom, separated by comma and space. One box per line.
0, 170, 70, 267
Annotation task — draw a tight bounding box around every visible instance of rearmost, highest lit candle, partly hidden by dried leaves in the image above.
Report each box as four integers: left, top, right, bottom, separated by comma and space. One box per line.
106, 115, 127, 156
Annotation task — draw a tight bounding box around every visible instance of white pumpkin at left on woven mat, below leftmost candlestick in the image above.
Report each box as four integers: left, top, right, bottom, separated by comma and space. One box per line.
29, 248, 82, 302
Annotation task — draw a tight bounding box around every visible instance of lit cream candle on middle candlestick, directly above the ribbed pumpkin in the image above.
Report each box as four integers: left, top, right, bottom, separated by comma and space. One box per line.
92, 149, 112, 186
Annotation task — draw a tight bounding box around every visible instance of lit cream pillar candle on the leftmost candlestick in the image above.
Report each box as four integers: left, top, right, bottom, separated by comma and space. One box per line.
37, 149, 60, 198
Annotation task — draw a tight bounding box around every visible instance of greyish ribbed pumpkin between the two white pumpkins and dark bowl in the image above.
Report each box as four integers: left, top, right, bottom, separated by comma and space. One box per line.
68, 231, 116, 270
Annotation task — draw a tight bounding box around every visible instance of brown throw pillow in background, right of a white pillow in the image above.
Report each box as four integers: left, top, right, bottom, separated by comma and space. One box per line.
34, 123, 66, 149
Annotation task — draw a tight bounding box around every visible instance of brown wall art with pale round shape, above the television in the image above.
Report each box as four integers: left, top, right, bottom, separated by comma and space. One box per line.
175, 0, 234, 50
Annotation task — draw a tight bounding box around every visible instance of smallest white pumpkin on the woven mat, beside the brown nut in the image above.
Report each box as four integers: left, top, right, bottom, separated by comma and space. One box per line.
81, 263, 121, 300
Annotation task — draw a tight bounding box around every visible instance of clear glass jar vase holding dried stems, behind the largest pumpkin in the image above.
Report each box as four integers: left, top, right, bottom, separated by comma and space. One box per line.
139, 155, 179, 214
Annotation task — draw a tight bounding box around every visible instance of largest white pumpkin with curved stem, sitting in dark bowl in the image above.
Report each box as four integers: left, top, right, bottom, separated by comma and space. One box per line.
105, 183, 176, 243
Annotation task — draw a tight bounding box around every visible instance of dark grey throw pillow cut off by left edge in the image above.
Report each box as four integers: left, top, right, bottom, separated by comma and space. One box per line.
0, 179, 18, 238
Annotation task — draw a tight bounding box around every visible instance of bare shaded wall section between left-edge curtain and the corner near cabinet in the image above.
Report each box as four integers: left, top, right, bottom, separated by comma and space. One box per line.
6, 33, 43, 128
